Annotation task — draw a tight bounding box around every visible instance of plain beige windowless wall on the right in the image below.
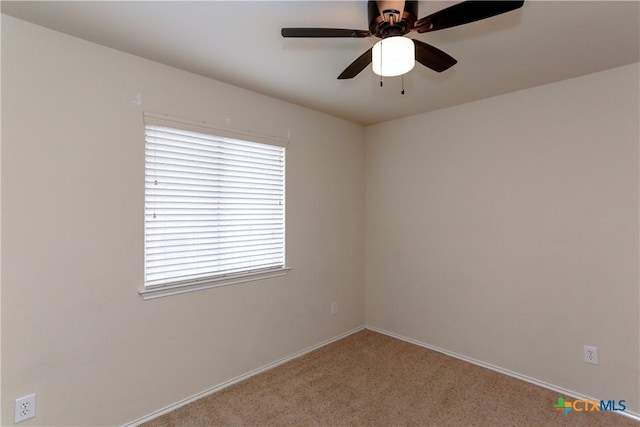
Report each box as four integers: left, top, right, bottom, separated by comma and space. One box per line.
366, 64, 640, 413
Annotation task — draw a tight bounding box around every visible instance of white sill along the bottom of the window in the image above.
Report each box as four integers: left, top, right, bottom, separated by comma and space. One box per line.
138, 267, 291, 300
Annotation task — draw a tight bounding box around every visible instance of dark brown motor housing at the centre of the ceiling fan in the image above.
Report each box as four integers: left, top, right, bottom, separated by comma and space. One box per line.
367, 0, 418, 39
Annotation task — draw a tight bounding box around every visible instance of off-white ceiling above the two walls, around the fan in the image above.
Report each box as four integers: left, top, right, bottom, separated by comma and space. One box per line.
2, 0, 640, 125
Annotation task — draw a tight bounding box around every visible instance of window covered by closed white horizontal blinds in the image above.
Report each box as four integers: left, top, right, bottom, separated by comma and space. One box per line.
141, 113, 286, 298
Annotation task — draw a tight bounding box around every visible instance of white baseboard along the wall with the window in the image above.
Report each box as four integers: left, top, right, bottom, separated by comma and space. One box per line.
123, 325, 365, 427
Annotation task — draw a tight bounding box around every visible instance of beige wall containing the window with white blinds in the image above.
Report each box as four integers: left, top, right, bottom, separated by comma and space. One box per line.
0, 16, 364, 426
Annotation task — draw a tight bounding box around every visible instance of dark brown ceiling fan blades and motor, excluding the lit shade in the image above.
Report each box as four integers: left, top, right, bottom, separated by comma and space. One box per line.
282, 0, 524, 79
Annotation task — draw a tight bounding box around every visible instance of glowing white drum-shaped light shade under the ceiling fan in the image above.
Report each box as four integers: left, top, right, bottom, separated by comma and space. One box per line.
371, 36, 416, 77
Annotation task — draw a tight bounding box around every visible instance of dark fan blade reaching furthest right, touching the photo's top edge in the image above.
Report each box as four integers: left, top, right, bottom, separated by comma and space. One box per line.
413, 0, 524, 33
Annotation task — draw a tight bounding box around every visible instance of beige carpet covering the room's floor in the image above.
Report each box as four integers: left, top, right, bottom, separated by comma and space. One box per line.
145, 330, 640, 427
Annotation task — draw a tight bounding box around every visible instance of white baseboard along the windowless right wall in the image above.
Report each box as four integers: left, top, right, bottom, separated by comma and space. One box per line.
366, 325, 640, 421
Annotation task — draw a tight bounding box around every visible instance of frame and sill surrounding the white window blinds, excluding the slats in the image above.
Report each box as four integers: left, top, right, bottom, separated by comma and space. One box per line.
138, 112, 291, 300
